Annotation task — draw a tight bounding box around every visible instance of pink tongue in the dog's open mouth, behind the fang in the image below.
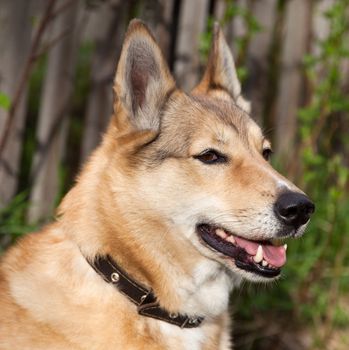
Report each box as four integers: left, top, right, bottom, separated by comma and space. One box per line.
234, 236, 286, 267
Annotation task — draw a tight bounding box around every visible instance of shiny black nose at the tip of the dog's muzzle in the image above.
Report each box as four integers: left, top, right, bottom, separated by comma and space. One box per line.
274, 192, 315, 229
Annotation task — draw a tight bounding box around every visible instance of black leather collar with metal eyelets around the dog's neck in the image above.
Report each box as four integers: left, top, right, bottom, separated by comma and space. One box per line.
87, 255, 204, 328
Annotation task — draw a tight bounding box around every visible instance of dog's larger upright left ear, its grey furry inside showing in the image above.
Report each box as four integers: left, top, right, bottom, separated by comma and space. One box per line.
114, 19, 175, 131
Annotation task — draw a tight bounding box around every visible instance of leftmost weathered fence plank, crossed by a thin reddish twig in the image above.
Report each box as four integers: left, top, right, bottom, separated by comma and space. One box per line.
0, 0, 31, 208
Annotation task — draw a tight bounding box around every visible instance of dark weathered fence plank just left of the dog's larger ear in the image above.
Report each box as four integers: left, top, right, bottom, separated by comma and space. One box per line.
80, 0, 129, 162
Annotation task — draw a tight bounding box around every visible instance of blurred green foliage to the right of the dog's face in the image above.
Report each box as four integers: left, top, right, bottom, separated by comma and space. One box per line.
237, 0, 349, 349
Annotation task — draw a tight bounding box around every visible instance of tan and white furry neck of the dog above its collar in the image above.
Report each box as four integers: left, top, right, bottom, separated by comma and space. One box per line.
61, 149, 232, 318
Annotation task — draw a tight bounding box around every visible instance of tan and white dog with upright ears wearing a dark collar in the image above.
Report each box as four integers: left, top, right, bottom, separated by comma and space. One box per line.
0, 20, 314, 350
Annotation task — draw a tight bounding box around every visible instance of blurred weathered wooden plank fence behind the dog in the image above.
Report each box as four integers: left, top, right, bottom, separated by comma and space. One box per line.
0, 0, 342, 221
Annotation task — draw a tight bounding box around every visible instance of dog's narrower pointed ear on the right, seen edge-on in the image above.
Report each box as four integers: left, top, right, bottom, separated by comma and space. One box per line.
194, 22, 251, 113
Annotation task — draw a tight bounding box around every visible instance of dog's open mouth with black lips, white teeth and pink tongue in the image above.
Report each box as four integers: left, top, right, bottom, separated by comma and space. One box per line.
197, 224, 287, 278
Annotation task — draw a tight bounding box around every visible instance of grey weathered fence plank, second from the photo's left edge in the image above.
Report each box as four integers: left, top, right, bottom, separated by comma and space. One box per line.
28, 1, 80, 222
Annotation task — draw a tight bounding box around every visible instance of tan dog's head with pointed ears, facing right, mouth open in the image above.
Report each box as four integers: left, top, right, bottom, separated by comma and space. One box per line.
108, 20, 314, 281
